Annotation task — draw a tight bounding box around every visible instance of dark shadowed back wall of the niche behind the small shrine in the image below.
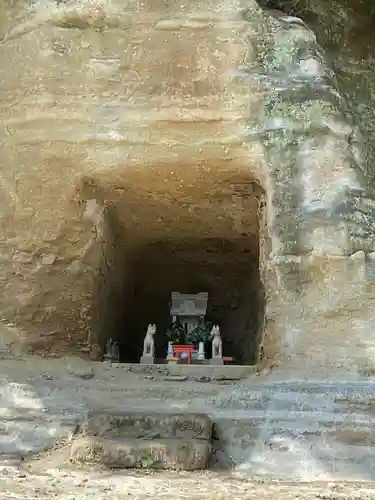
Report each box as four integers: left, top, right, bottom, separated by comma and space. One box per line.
119, 238, 265, 364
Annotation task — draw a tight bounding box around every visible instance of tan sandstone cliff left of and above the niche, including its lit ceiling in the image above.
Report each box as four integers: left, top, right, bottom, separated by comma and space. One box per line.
0, 2, 264, 360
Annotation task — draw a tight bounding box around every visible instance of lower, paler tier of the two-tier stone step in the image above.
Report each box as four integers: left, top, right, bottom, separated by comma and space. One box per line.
70, 436, 210, 470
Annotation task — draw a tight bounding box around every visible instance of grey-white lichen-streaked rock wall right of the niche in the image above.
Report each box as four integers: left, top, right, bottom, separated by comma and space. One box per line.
253, 7, 374, 375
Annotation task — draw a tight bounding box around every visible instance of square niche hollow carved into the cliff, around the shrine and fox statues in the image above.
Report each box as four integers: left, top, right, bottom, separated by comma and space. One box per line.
92, 166, 266, 364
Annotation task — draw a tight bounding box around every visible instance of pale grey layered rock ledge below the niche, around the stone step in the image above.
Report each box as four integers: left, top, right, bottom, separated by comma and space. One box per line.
0, 357, 375, 480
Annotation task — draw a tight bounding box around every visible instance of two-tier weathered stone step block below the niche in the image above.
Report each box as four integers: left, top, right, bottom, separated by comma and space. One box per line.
71, 410, 213, 470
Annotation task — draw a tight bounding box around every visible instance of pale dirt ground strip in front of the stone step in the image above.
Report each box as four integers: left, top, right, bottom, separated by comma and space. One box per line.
0, 466, 375, 500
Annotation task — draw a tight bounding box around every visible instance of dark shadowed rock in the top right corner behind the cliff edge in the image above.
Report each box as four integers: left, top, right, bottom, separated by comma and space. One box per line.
259, 0, 375, 186
